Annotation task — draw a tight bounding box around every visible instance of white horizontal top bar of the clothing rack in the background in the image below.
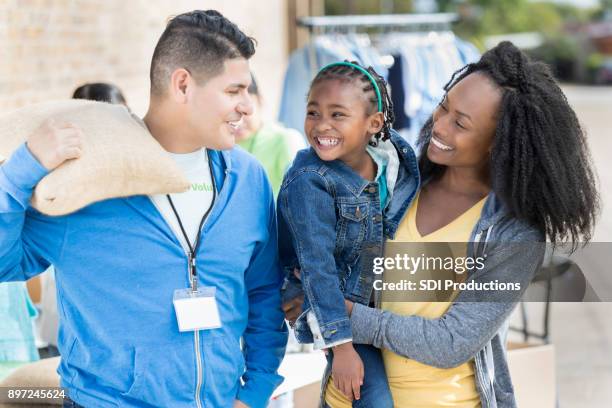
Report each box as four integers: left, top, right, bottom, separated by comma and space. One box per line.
297, 13, 459, 34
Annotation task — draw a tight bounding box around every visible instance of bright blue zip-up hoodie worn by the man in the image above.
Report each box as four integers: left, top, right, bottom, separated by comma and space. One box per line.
0, 144, 287, 408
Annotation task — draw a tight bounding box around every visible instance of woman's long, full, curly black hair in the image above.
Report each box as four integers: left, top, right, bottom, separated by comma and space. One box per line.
418, 41, 599, 248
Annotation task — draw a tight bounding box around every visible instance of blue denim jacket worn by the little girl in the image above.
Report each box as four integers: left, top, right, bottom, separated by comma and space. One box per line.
278, 132, 419, 345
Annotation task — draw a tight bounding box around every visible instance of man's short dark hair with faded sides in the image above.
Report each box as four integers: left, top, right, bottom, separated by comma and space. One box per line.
150, 10, 255, 95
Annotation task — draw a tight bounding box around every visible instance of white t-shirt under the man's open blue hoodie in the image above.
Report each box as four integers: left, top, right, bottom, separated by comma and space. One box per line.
150, 149, 213, 253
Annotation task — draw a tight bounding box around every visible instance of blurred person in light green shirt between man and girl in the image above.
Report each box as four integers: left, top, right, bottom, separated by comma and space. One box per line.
236, 74, 307, 197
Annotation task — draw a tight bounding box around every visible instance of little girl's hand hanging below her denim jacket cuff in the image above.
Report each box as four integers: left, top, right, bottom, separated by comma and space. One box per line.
332, 342, 364, 401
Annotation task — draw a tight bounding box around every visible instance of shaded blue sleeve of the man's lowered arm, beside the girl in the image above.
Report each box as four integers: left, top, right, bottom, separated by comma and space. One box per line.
236, 180, 288, 408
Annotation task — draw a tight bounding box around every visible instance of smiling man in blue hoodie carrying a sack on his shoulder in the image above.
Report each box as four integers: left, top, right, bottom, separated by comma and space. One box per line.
0, 11, 287, 408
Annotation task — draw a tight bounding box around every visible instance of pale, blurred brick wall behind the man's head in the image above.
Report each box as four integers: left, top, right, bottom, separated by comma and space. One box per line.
0, 0, 288, 116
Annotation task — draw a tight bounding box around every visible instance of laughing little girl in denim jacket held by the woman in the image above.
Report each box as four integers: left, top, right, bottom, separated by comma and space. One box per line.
278, 61, 419, 408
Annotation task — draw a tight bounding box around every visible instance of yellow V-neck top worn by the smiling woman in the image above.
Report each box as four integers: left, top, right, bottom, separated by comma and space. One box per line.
325, 191, 485, 408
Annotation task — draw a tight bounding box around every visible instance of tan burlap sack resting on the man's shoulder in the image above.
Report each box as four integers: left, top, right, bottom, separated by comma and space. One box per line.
0, 100, 189, 215
